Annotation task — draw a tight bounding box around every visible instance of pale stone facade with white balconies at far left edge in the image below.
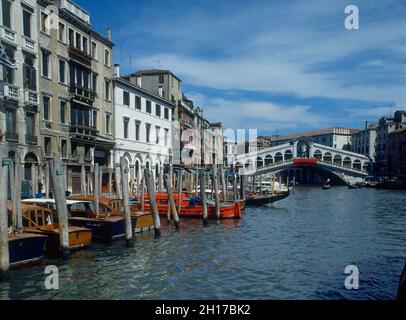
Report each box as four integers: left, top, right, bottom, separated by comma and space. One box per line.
0, 0, 41, 180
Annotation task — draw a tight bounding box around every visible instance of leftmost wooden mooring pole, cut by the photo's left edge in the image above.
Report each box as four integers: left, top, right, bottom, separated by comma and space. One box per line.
0, 145, 10, 276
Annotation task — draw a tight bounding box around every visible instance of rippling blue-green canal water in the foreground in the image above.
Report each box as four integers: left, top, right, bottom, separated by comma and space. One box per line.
0, 187, 406, 299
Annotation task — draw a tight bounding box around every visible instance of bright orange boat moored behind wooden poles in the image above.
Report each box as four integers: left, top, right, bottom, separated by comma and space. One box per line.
140, 193, 242, 219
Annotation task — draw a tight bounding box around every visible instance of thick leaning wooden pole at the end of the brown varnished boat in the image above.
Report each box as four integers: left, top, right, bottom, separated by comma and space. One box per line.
50, 159, 69, 258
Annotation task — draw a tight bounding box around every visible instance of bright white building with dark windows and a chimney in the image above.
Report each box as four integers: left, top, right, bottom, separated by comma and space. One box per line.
113, 66, 175, 177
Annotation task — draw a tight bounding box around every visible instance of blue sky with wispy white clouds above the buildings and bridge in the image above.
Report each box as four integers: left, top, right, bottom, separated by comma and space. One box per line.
77, 0, 406, 134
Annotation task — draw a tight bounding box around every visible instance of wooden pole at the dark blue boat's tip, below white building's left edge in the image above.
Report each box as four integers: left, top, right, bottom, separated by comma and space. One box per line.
120, 157, 133, 247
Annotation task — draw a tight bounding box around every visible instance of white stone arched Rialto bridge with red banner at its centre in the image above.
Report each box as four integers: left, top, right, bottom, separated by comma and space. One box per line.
234, 138, 371, 185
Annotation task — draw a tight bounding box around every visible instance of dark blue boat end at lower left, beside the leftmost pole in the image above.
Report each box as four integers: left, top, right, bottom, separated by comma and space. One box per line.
8, 233, 48, 268
